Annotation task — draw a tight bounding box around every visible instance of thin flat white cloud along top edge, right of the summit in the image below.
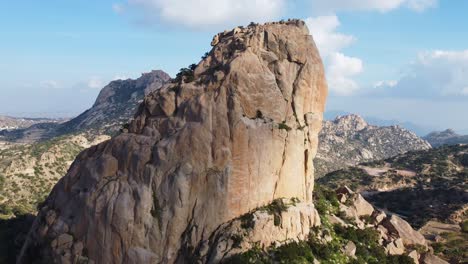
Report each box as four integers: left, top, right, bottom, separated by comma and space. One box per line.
311, 0, 438, 14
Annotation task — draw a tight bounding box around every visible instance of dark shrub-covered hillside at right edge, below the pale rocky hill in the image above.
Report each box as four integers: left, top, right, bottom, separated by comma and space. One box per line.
318, 145, 468, 263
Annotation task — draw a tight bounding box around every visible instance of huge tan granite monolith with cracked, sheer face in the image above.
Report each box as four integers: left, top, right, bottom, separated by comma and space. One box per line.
17, 20, 327, 263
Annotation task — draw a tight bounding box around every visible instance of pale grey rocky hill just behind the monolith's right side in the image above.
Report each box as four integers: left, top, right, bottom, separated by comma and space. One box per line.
314, 115, 431, 178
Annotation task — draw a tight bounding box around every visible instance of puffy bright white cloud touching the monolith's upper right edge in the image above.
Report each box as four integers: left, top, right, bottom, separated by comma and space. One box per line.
305, 15, 363, 95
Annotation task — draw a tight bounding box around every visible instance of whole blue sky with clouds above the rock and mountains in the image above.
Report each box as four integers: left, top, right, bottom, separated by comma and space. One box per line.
0, 0, 468, 132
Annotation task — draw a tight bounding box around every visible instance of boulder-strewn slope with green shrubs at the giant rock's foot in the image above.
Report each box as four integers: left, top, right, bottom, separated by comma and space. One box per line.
222, 186, 447, 264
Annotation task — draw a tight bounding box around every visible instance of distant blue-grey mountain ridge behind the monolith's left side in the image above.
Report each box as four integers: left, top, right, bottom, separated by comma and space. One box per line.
0, 70, 170, 143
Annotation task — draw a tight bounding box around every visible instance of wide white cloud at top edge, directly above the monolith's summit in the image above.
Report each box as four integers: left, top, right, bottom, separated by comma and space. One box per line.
121, 0, 286, 28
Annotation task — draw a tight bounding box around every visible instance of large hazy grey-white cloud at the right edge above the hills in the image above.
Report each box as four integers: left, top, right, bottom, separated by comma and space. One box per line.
374, 50, 468, 99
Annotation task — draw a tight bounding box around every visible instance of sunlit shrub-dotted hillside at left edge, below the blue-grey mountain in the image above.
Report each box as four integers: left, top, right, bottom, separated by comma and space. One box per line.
0, 134, 109, 218
